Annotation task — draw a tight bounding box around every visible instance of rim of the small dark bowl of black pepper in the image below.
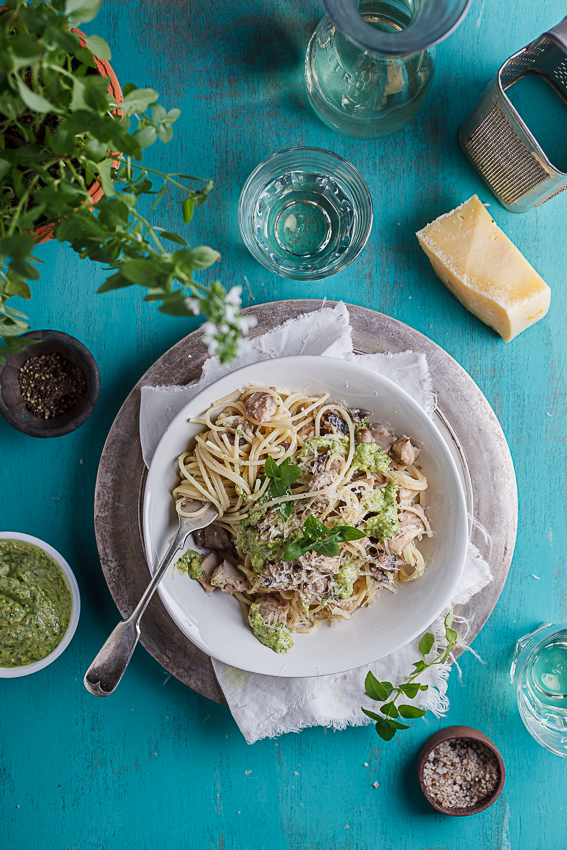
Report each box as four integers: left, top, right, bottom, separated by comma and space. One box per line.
0, 328, 100, 438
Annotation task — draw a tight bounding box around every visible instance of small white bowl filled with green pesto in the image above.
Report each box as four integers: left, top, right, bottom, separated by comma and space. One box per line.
0, 531, 81, 679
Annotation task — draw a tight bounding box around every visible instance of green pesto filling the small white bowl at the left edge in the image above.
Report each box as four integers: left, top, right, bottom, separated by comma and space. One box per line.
0, 539, 73, 667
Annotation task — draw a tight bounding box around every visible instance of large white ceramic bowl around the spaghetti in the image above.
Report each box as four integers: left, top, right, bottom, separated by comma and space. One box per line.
143, 356, 468, 677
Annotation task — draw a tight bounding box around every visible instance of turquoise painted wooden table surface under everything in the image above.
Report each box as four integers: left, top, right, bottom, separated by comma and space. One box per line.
0, 0, 567, 850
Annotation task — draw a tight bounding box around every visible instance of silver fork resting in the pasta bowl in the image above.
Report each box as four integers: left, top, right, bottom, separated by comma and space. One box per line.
83, 502, 219, 697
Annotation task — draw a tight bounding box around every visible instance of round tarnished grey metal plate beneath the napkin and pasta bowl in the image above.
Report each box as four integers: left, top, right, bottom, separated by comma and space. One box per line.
95, 300, 518, 704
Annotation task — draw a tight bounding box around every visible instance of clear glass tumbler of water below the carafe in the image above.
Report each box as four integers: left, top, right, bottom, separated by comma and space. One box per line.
238, 147, 372, 280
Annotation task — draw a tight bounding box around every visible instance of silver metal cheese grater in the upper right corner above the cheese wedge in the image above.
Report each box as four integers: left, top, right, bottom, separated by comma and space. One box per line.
459, 18, 567, 212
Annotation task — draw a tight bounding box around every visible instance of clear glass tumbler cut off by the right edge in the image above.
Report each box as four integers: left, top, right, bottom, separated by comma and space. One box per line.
510, 623, 567, 758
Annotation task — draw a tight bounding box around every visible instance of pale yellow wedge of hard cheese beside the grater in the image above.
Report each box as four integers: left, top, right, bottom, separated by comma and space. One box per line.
417, 195, 551, 342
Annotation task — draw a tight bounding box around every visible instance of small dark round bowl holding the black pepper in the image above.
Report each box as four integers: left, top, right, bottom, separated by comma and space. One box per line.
0, 330, 100, 437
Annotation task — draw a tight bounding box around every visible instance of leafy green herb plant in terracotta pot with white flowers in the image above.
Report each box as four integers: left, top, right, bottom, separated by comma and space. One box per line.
0, 0, 251, 363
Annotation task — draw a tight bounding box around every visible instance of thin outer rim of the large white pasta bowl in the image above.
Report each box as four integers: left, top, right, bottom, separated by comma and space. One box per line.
141, 355, 469, 678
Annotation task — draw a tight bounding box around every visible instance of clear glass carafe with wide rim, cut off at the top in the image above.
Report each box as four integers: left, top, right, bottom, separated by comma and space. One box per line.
305, 0, 471, 139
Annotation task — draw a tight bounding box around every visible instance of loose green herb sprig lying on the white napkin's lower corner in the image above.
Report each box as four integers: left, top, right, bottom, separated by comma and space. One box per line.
362, 608, 458, 741
